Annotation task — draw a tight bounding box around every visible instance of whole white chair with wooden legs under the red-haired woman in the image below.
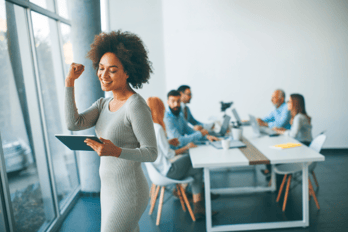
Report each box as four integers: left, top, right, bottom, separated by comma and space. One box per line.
144, 163, 196, 226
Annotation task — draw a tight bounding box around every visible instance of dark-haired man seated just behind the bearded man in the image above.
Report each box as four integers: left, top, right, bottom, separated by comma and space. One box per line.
178, 85, 214, 131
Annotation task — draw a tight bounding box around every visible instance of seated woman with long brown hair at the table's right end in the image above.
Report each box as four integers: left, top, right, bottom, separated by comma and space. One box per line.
273, 93, 312, 146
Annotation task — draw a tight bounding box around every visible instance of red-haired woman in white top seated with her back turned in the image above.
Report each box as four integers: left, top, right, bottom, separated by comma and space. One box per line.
147, 97, 213, 220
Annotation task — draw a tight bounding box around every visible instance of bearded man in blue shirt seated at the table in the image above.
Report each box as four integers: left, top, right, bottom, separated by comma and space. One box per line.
164, 90, 218, 148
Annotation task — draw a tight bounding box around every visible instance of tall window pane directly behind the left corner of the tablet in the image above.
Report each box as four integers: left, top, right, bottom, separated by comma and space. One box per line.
31, 12, 79, 208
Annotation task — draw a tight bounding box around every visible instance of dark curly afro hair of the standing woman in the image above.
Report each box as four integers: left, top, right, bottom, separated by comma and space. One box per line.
87, 30, 152, 89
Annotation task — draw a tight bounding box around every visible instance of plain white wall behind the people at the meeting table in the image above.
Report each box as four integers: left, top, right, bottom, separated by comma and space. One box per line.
162, 0, 348, 148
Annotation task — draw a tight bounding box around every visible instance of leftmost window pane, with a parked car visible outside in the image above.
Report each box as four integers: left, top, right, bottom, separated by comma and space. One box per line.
0, 0, 55, 232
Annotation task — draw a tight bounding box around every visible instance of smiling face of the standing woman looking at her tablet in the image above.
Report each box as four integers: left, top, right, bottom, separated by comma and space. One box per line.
97, 52, 128, 91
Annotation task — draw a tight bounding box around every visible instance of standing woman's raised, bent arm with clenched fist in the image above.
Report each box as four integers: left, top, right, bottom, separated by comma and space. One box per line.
65, 63, 101, 131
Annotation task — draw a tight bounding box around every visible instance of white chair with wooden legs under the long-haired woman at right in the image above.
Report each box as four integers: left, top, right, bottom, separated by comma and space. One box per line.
273, 134, 326, 211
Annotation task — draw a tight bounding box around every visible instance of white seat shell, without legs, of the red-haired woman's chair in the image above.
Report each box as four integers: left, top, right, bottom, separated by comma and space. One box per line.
144, 162, 193, 186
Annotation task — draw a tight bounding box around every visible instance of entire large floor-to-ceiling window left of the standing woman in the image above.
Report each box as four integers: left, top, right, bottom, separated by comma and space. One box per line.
0, 0, 79, 232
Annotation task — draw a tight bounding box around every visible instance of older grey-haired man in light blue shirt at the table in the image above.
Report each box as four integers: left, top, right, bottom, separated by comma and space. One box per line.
257, 89, 291, 129
